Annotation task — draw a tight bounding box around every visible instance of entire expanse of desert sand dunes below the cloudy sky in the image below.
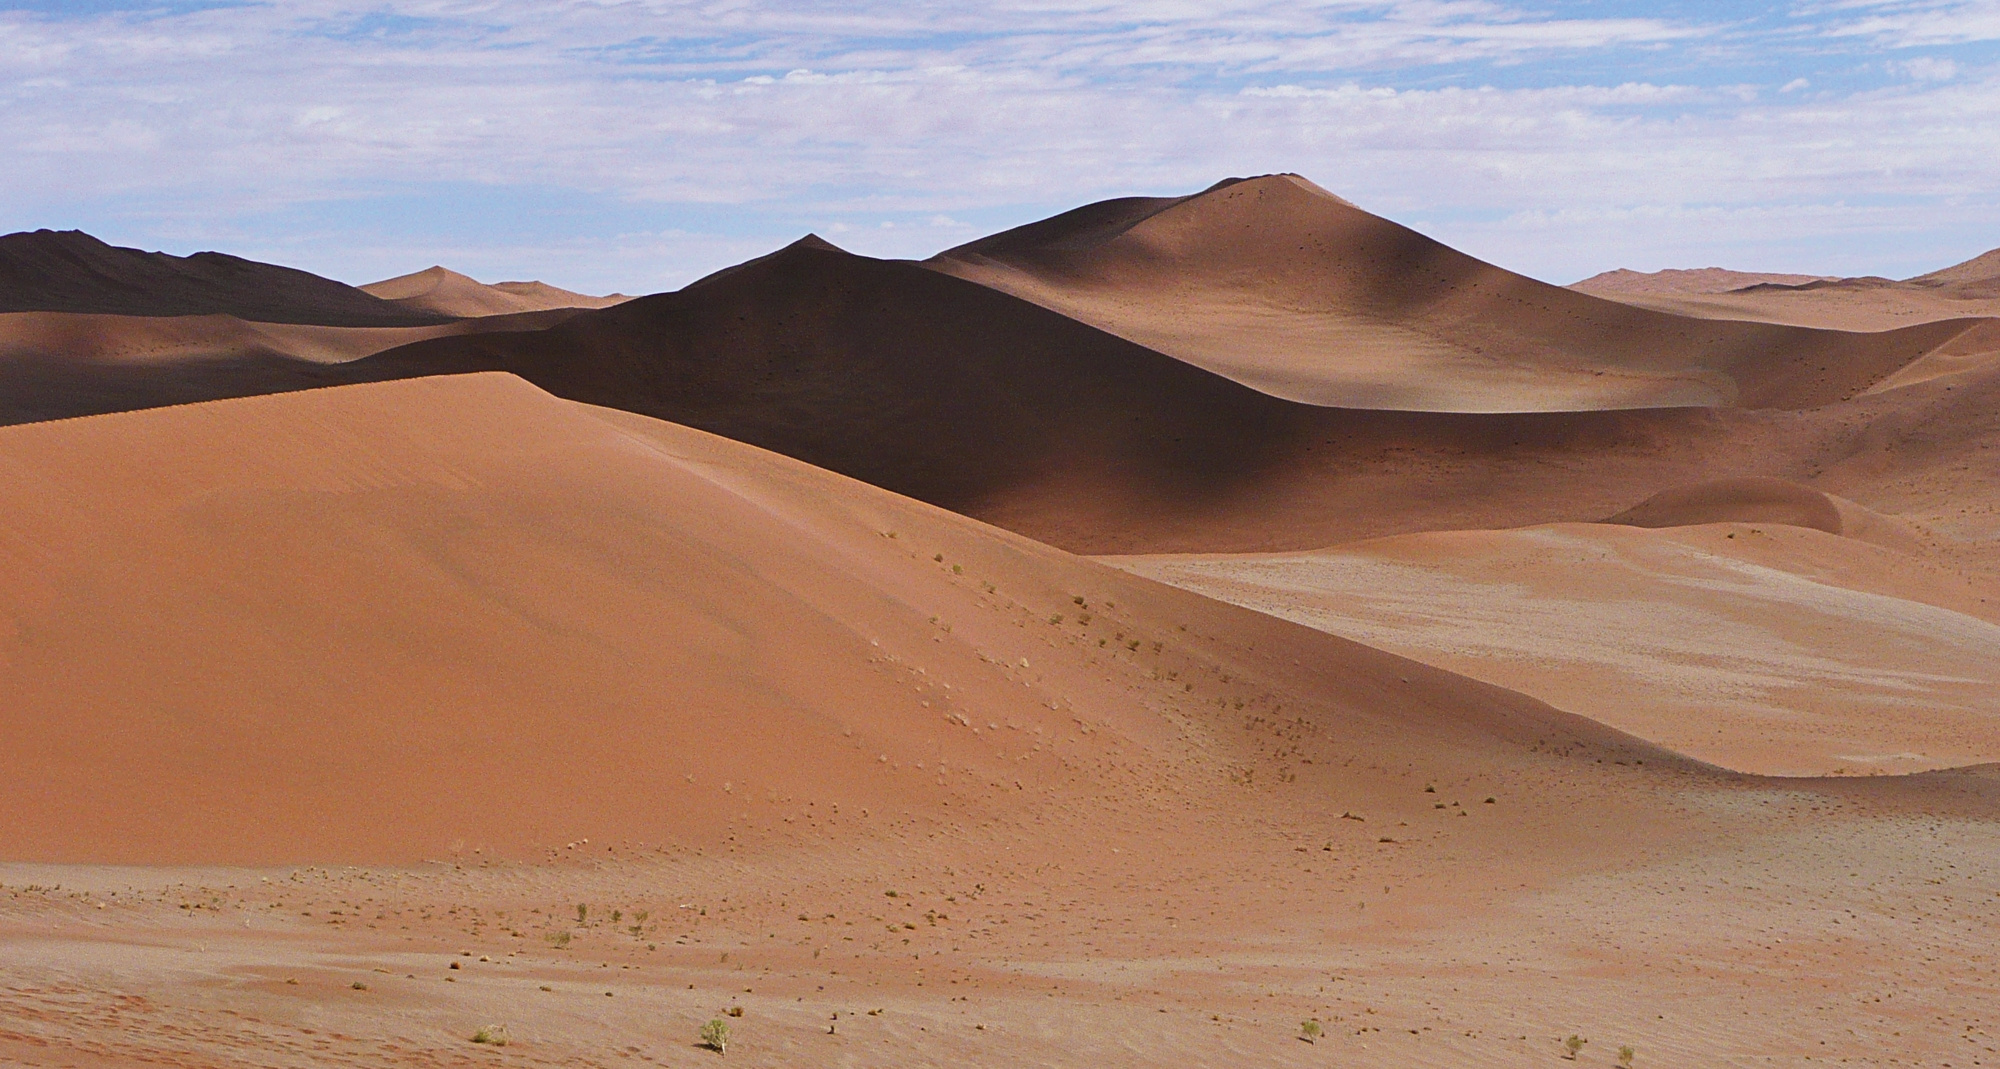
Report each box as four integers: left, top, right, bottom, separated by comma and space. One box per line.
0, 174, 2000, 1069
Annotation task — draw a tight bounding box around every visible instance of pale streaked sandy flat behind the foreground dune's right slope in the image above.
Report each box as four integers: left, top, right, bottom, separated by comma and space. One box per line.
1118, 520, 2000, 775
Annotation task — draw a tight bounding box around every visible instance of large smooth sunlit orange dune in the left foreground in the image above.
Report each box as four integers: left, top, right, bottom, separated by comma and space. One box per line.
0, 374, 1674, 863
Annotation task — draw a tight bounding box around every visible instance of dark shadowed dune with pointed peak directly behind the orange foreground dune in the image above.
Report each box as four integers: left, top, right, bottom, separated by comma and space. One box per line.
350, 240, 1806, 553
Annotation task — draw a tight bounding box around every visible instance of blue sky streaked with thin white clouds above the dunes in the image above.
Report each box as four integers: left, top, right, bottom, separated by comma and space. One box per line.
0, 0, 2000, 292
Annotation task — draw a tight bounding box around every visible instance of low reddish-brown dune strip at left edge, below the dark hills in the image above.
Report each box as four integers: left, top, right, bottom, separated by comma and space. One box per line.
0, 310, 576, 424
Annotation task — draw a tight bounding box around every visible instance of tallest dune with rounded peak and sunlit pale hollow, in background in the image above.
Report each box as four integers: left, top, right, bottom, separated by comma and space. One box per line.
926, 174, 1970, 412
